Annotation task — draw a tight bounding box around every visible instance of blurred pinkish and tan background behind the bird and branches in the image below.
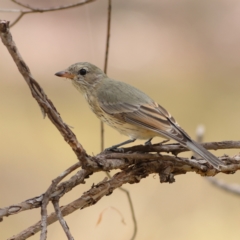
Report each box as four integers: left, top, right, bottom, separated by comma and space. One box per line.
0, 0, 240, 240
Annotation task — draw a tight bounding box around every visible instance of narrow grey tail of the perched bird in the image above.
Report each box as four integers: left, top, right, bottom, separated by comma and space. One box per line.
186, 140, 225, 170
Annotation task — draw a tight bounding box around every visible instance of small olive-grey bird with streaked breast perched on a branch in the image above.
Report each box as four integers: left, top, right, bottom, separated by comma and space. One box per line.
55, 62, 225, 170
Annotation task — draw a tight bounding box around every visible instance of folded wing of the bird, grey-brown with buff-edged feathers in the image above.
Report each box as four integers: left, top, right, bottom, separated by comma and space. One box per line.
99, 98, 190, 145
